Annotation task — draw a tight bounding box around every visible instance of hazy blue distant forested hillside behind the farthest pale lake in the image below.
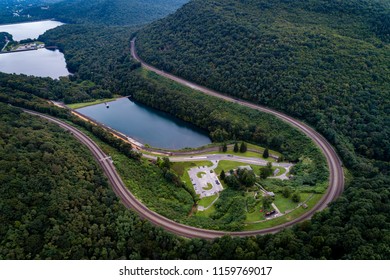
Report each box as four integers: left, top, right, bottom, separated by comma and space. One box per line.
26, 0, 188, 25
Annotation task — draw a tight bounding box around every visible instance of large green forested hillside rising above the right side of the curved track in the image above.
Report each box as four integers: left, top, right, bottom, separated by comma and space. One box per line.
137, 0, 390, 172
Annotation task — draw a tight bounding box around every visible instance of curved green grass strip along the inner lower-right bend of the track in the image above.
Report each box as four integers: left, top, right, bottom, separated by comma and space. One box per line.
243, 194, 322, 231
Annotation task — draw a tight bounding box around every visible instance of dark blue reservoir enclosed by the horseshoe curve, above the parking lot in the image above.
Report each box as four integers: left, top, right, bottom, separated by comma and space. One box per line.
77, 98, 211, 150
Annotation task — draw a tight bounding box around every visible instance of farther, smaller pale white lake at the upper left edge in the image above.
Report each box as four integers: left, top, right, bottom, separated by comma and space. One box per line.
0, 20, 63, 41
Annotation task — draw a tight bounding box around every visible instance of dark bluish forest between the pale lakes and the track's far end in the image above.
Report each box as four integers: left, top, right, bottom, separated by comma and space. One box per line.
39, 24, 140, 95
